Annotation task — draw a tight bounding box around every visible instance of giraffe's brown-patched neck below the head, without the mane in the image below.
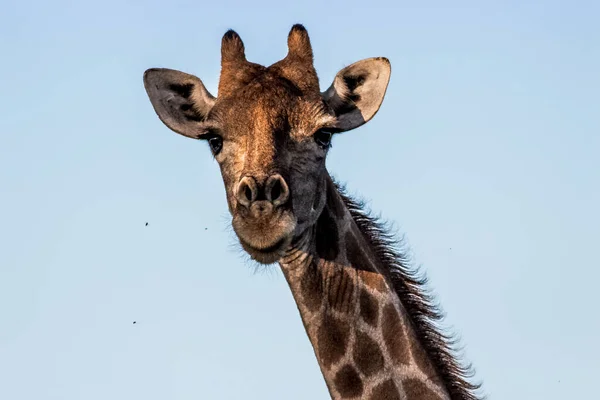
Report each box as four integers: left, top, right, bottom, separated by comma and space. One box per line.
280, 177, 449, 400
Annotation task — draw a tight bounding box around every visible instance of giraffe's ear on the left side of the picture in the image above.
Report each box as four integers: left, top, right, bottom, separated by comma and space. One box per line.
144, 68, 216, 139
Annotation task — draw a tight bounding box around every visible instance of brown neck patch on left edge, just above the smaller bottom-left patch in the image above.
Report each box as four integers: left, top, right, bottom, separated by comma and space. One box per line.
317, 315, 350, 368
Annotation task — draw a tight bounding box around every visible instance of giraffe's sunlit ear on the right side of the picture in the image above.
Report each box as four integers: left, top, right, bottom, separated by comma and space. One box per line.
322, 57, 392, 132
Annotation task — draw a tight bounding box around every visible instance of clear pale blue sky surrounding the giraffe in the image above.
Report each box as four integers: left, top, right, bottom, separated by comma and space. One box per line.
0, 0, 600, 400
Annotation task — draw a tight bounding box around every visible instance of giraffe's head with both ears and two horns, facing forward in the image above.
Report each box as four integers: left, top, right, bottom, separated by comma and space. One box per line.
144, 25, 391, 263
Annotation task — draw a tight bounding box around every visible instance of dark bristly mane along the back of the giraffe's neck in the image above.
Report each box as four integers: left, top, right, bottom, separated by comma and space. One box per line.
332, 178, 481, 400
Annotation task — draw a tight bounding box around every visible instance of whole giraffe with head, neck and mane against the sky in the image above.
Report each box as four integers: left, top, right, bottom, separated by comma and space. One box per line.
144, 24, 480, 400
